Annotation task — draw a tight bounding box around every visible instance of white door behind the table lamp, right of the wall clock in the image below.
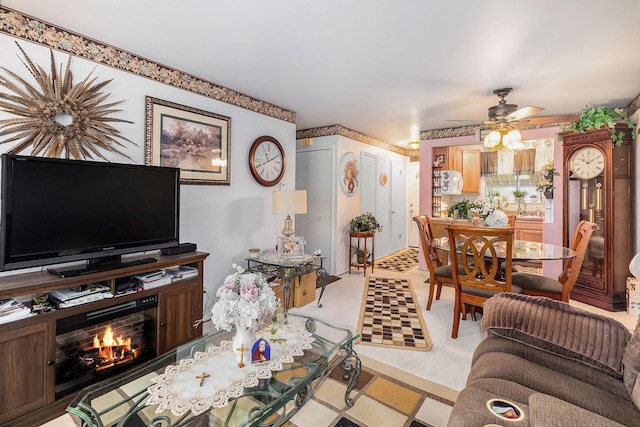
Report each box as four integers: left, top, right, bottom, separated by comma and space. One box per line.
295, 148, 337, 274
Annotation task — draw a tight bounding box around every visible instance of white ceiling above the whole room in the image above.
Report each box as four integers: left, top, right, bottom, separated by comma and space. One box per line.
7, 0, 640, 146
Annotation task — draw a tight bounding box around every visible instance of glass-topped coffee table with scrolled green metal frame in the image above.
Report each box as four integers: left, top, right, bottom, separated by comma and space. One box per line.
67, 313, 362, 427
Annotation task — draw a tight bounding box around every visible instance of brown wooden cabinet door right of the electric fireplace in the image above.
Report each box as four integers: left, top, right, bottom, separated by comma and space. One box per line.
158, 284, 202, 354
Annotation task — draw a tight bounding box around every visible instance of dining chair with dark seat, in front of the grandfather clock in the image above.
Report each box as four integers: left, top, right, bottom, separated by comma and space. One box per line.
512, 221, 600, 302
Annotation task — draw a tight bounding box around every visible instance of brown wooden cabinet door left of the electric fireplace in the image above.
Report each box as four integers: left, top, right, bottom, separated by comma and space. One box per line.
0, 323, 55, 425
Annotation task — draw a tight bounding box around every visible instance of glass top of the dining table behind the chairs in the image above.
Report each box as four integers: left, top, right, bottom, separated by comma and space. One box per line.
429, 237, 577, 261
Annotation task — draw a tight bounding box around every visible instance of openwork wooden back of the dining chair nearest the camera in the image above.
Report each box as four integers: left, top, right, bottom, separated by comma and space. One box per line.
448, 224, 513, 292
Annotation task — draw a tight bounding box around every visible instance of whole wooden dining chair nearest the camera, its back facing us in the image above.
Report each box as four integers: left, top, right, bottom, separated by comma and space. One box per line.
447, 224, 522, 338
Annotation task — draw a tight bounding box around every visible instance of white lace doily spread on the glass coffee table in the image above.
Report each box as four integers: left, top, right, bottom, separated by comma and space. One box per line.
146, 325, 314, 416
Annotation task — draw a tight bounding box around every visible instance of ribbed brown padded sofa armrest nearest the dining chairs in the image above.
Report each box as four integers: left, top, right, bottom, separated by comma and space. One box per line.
481, 293, 631, 378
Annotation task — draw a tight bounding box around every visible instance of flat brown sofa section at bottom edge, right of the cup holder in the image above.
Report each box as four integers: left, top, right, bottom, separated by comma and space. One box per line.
529, 393, 622, 427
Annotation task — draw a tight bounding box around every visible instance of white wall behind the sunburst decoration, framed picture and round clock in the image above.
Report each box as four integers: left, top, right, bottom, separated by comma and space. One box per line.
0, 34, 296, 309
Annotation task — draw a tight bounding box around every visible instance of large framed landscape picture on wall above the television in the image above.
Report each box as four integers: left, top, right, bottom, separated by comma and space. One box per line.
144, 96, 231, 185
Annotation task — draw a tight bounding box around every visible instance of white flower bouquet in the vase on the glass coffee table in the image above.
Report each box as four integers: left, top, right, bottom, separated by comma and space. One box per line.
211, 264, 277, 331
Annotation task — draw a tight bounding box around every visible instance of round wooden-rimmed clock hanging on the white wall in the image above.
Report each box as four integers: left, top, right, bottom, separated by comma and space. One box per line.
249, 135, 286, 187
